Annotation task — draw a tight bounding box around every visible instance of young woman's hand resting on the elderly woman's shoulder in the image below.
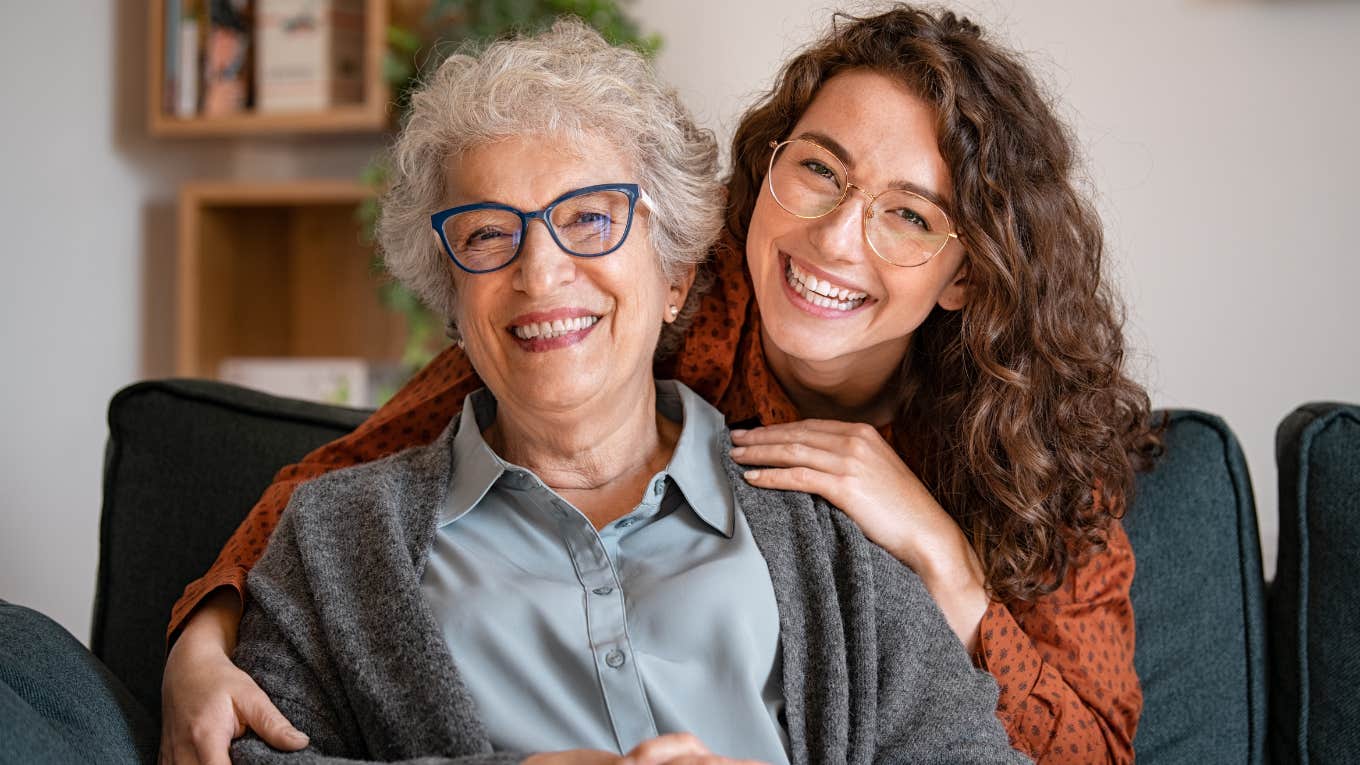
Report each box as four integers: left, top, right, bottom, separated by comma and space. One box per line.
732, 419, 987, 651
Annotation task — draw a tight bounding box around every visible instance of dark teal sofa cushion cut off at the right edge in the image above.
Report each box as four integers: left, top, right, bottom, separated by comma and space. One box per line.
1270, 403, 1360, 762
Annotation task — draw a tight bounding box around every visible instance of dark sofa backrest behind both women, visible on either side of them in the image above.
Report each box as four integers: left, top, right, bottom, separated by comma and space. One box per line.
91, 380, 1265, 762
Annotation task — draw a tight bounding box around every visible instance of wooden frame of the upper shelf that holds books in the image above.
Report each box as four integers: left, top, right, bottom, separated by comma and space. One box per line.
147, 0, 390, 137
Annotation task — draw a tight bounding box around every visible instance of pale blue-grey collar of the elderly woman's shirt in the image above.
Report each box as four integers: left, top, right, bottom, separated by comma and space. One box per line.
438, 380, 737, 538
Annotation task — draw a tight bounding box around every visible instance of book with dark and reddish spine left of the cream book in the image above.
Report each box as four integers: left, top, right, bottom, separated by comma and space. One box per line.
203, 0, 253, 117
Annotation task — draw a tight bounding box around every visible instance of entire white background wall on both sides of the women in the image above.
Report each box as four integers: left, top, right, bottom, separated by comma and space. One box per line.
0, 0, 1360, 638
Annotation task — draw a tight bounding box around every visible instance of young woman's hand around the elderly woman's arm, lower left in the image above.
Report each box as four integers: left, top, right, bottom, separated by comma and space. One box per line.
160, 592, 307, 765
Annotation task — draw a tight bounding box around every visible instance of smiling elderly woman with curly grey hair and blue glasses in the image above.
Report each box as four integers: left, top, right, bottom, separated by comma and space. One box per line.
233, 17, 1021, 764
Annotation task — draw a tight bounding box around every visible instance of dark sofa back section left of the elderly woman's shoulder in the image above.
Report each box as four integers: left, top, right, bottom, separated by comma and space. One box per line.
90, 380, 369, 719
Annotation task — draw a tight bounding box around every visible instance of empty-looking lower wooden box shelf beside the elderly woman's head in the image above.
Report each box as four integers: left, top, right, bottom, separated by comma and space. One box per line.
175, 181, 405, 377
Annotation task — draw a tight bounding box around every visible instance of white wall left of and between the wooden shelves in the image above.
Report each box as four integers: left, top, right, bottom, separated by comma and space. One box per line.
0, 0, 382, 640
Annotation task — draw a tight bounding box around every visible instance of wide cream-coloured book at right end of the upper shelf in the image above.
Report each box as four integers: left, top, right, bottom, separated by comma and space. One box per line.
256, 0, 363, 112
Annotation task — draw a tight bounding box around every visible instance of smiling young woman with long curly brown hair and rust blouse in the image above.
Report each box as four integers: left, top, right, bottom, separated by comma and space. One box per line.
163, 7, 1157, 762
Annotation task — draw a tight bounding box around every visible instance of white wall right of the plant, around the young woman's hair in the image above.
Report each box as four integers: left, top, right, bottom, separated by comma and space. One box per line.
636, 0, 1360, 576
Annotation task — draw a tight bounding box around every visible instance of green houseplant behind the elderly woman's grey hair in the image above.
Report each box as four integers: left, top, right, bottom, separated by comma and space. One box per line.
359, 0, 661, 381
